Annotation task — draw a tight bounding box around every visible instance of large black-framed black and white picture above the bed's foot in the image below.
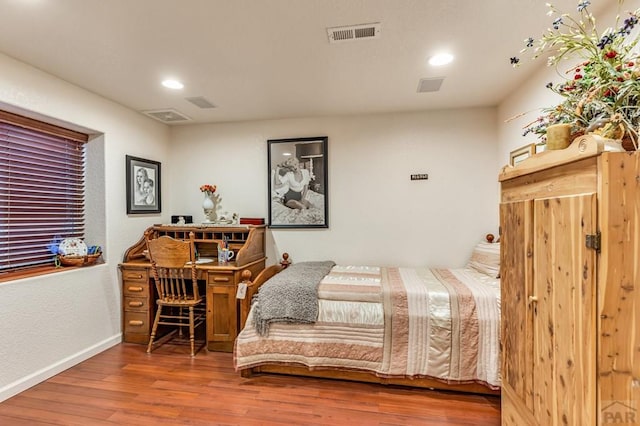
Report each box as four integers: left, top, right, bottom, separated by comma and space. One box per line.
267, 136, 329, 228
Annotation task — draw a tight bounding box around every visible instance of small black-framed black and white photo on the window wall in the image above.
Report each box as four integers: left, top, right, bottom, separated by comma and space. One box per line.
126, 155, 161, 214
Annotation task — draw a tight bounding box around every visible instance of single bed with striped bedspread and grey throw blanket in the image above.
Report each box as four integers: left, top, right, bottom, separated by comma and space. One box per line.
234, 242, 500, 394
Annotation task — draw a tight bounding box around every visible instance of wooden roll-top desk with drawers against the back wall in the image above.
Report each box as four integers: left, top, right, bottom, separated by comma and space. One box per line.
119, 225, 266, 352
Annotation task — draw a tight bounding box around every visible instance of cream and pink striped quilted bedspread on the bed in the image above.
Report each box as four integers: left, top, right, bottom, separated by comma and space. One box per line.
234, 265, 500, 388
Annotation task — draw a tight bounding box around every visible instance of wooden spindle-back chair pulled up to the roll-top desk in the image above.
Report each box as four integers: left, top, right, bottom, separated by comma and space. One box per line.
145, 232, 206, 356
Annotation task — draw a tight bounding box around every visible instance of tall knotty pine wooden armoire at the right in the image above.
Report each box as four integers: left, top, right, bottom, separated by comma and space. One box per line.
499, 135, 640, 426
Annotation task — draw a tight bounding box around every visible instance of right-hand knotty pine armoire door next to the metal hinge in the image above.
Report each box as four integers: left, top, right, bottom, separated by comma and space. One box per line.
532, 194, 597, 425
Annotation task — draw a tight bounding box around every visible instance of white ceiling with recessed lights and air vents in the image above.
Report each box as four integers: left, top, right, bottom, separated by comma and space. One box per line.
0, 0, 615, 123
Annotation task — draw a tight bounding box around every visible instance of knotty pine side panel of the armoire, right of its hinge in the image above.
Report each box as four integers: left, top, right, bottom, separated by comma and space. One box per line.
596, 152, 640, 406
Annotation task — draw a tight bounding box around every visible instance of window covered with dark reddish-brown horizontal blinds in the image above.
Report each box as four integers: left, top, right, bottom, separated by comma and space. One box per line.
0, 111, 88, 273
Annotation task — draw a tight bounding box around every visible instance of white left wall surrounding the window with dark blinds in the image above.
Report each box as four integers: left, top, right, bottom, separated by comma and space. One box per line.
0, 54, 171, 401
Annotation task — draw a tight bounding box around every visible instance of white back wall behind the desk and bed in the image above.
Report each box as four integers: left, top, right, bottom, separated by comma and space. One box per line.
169, 108, 499, 266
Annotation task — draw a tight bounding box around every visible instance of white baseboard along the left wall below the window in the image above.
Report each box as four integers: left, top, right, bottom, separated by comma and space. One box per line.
0, 333, 122, 402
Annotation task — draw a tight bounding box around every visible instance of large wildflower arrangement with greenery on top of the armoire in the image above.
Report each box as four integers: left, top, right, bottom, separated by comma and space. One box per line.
511, 0, 640, 149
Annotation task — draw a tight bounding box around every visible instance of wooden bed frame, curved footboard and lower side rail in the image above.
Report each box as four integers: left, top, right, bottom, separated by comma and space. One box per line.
235, 253, 500, 395
